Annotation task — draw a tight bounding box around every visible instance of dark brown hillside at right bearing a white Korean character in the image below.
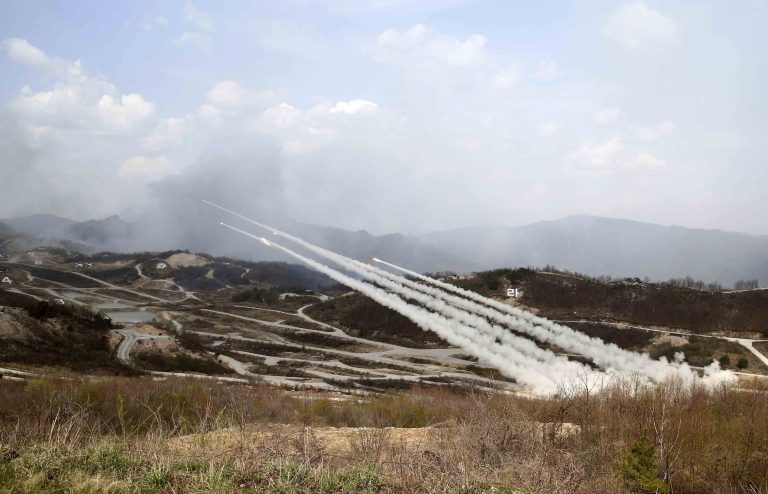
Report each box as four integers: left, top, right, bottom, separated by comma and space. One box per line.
458, 269, 768, 337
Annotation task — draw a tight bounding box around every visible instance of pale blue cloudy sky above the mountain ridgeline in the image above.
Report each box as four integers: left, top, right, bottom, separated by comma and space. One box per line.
0, 0, 768, 235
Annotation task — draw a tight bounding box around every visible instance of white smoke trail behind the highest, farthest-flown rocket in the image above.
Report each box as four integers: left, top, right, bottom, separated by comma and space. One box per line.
205, 201, 596, 382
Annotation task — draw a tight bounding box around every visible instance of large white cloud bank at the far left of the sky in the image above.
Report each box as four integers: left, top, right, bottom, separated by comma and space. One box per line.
0, 39, 170, 217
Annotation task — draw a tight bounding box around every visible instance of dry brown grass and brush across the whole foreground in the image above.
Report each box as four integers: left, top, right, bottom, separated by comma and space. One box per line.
0, 378, 768, 494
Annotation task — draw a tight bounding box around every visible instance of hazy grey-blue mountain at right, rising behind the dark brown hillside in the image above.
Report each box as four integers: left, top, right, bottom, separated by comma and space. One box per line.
420, 215, 768, 286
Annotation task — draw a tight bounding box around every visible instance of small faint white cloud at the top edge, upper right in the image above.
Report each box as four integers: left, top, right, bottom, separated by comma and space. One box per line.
603, 2, 679, 50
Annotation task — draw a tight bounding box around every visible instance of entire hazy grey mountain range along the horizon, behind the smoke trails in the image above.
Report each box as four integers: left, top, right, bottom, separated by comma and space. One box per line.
0, 214, 768, 286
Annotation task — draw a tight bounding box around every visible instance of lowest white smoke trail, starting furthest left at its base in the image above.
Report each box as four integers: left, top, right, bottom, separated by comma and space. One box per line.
222, 223, 558, 393
